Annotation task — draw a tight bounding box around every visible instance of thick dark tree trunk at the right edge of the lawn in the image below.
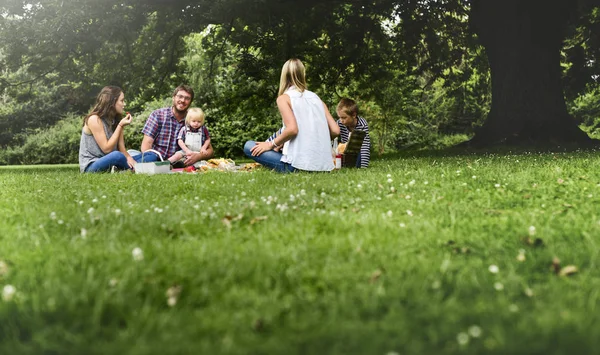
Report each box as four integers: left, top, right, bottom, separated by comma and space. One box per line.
469, 0, 592, 147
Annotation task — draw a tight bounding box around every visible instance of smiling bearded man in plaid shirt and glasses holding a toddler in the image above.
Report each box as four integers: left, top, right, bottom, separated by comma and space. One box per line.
134, 85, 213, 166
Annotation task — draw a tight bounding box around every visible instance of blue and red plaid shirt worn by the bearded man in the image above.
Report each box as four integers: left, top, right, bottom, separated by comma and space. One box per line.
142, 107, 185, 159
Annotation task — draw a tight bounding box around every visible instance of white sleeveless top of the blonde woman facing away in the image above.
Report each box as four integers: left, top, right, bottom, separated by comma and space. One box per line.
281, 87, 334, 171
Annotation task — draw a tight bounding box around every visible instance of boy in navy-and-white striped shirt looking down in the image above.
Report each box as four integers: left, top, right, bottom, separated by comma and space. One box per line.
336, 98, 371, 168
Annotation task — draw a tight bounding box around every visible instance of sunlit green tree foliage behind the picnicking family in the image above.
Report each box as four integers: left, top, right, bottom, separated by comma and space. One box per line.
0, 0, 600, 163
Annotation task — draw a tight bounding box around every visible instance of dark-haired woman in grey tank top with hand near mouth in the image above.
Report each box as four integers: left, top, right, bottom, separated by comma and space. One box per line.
79, 86, 135, 173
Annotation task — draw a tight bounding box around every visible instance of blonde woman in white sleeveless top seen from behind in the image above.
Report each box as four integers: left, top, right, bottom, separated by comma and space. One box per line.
244, 58, 340, 173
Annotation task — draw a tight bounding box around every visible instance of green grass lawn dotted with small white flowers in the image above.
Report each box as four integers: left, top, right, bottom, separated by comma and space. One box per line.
0, 152, 600, 355
